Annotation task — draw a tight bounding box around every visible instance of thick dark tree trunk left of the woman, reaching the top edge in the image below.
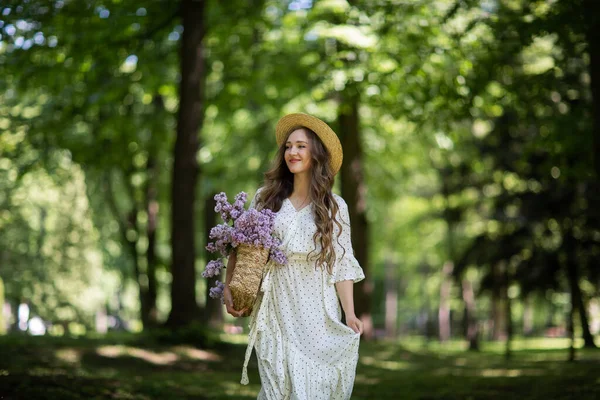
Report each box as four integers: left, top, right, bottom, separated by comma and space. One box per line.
167, 0, 205, 328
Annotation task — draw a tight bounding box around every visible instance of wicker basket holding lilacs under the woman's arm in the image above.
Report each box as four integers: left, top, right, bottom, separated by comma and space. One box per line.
229, 244, 269, 315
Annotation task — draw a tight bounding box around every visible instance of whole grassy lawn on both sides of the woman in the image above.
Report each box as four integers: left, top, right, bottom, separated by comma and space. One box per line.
0, 335, 600, 400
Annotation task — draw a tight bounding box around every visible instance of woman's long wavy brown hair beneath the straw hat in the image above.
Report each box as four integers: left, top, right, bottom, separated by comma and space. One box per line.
256, 127, 346, 274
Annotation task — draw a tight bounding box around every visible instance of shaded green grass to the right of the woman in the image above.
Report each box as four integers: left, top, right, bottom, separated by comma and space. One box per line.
353, 341, 600, 400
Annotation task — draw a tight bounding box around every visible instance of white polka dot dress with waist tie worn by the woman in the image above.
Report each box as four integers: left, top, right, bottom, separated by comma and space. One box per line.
242, 190, 364, 400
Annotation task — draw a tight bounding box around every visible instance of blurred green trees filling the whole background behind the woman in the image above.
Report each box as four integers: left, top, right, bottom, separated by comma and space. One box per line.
0, 0, 600, 354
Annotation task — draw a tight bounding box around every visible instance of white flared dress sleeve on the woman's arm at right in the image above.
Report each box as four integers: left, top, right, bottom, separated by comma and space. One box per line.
329, 196, 365, 285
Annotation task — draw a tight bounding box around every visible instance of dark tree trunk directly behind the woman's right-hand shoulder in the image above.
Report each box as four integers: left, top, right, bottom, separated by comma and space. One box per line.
338, 95, 374, 339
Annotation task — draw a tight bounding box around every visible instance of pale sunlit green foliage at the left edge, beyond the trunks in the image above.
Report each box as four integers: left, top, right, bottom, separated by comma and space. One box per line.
0, 139, 118, 326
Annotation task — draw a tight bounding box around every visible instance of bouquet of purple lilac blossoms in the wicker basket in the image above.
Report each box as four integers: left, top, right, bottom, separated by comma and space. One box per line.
202, 192, 287, 303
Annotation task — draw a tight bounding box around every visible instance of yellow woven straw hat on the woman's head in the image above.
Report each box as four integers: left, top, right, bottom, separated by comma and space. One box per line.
275, 113, 344, 175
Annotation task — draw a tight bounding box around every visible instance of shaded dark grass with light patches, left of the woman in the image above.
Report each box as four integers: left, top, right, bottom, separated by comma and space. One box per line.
0, 336, 259, 400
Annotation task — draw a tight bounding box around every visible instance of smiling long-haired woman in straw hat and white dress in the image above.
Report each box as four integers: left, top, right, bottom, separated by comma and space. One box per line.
224, 114, 364, 400
